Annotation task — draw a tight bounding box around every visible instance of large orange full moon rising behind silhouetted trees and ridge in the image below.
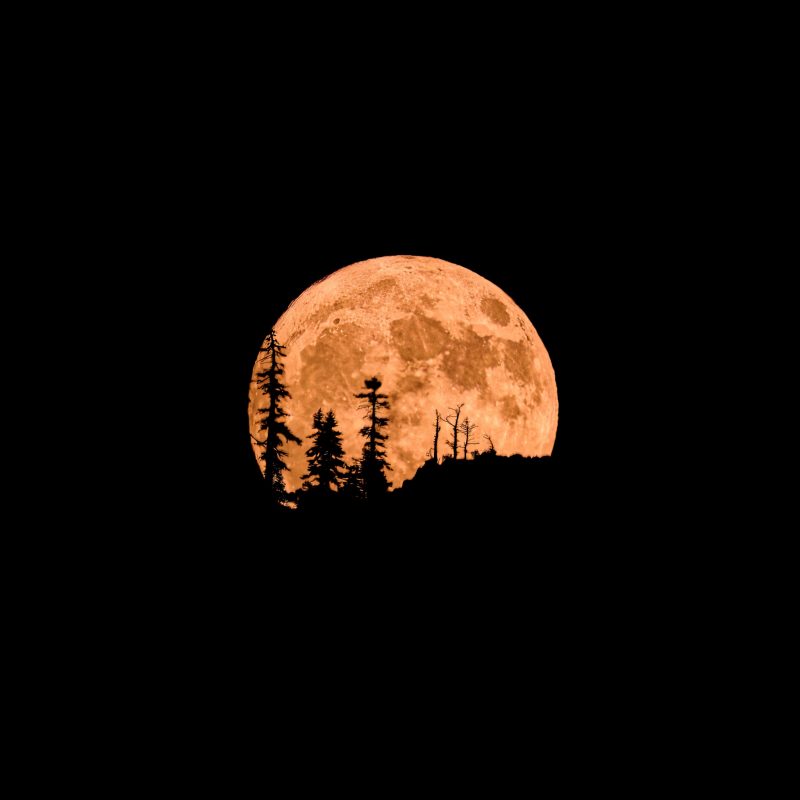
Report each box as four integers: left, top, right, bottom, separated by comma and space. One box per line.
249, 256, 558, 491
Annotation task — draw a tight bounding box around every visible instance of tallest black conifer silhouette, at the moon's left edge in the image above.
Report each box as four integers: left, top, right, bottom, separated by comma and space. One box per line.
251, 330, 302, 505
